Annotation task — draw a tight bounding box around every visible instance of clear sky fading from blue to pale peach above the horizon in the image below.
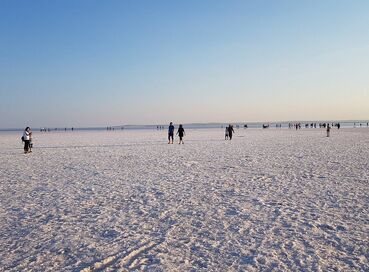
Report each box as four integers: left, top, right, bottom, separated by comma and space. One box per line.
0, 0, 369, 128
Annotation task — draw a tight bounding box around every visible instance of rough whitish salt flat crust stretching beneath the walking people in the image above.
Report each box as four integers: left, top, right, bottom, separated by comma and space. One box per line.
0, 128, 369, 271
